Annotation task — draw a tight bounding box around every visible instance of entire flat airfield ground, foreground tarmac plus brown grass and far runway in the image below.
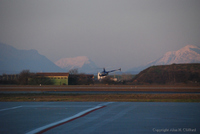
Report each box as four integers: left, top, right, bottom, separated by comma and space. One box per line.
0, 85, 200, 134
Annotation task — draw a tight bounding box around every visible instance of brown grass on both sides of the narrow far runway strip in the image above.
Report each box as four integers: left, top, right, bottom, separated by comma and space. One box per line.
0, 85, 200, 102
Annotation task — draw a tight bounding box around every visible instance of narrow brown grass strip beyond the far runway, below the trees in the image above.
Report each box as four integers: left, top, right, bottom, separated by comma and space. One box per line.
0, 85, 200, 91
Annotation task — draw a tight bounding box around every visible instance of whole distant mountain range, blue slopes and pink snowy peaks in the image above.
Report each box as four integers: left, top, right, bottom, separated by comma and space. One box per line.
0, 43, 200, 74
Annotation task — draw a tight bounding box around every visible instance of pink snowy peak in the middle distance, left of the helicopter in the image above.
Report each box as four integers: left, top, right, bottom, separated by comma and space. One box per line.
55, 56, 98, 73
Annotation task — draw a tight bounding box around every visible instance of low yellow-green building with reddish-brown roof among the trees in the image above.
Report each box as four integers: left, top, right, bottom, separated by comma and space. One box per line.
36, 73, 69, 85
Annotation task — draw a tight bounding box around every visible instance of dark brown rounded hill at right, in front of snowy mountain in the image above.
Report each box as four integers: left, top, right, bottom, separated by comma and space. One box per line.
133, 63, 200, 84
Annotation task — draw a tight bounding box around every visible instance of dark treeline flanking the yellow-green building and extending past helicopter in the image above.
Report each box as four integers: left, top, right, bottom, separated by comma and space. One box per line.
0, 69, 133, 85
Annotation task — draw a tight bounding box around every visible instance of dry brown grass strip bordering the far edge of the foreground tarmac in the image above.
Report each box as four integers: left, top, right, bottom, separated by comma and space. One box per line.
0, 94, 200, 102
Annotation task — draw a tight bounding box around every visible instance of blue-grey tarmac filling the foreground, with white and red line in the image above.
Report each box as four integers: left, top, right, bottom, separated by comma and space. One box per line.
0, 102, 200, 134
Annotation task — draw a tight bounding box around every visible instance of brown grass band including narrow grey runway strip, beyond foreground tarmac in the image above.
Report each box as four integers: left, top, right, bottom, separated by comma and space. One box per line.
0, 85, 200, 102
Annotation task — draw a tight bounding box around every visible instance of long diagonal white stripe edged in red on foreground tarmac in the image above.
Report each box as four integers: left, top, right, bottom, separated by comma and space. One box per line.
27, 102, 113, 134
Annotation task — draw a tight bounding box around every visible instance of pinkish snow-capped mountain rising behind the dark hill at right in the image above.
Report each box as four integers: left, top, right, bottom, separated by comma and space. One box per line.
127, 45, 200, 73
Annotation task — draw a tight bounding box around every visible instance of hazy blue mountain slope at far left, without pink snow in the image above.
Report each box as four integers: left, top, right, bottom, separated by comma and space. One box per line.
0, 43, 63, 74
